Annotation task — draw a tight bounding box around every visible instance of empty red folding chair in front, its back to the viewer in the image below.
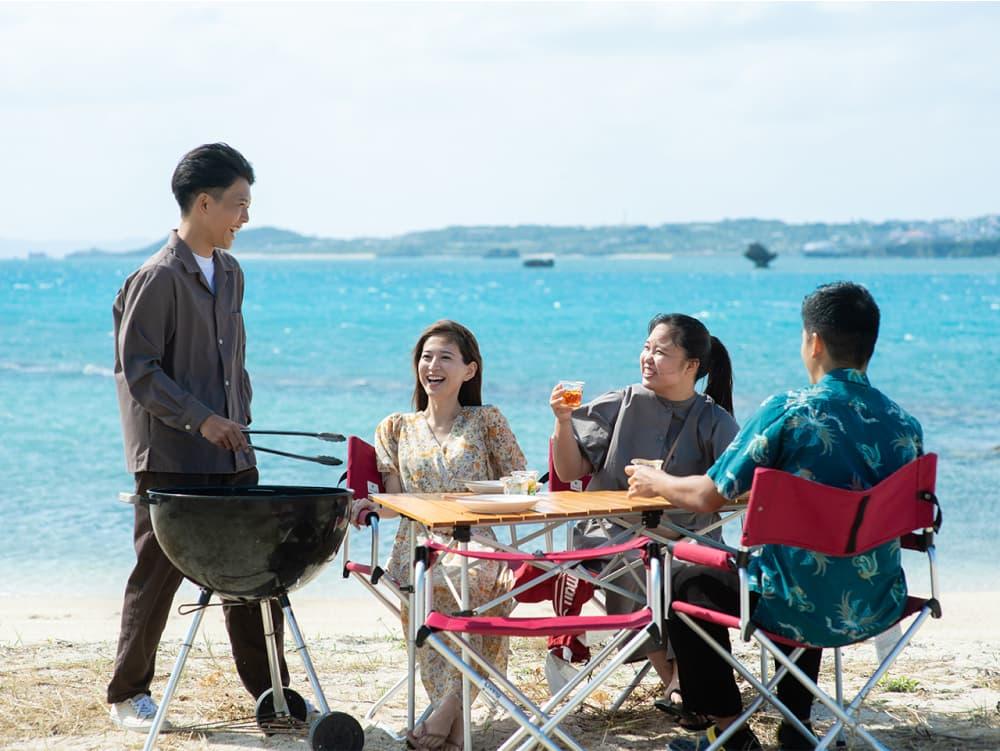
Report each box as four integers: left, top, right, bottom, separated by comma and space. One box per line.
414, 536, 664, 751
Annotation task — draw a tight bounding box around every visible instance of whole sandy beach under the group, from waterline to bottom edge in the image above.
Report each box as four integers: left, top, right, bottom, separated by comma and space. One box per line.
0, 590, 1000, 751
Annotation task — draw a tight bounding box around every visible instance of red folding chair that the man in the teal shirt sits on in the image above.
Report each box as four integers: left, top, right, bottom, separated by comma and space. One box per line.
668, 454, 941, 749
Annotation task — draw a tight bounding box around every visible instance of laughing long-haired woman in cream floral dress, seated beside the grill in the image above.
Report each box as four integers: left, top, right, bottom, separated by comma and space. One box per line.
364, 320, 525, 751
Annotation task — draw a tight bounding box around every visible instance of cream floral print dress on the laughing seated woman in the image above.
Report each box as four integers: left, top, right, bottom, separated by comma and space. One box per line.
375, 405, 525, 703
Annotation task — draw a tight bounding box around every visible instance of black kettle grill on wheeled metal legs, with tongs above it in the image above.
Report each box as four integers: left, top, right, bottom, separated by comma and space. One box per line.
123, 431, 364, 751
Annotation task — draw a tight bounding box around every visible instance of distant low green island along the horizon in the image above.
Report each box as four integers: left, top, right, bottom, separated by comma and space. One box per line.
69, 214, 1000, 259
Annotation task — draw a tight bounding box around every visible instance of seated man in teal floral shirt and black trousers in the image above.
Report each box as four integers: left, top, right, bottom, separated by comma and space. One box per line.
629, 282, 923, 751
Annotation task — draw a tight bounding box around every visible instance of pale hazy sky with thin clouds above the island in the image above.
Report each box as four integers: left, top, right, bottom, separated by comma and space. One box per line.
0, 2, 1000, 248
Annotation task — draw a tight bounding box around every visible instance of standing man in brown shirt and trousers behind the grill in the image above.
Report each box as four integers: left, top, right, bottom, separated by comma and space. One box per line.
107, 143, 288, 731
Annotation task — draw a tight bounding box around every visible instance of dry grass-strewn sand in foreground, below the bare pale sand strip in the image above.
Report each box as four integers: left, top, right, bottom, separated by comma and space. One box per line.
0, 635, 1000, 751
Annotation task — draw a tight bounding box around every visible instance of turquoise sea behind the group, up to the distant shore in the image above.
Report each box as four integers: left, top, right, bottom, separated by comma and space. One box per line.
0, 255, 1000, 596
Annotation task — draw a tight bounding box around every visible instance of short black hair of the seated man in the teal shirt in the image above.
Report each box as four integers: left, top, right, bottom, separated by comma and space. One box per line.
802, 282, 880, 368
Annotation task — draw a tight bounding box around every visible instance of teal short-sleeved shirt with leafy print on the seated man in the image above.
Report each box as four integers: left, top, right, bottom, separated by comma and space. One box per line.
708, 369, 923, 646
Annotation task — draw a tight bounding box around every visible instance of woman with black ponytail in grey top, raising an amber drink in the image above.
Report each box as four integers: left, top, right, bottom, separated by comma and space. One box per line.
547, 313, 739, 727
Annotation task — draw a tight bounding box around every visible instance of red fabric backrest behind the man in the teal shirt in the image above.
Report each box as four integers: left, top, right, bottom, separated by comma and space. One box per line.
742, 454, 937, 556
